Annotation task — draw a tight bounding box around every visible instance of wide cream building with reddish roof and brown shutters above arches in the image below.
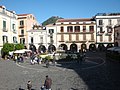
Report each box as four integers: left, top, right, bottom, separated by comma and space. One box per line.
56, 18, 96, 51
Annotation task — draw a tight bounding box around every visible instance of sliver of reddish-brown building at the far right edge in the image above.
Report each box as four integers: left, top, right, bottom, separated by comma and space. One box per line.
114, 23, 120, 47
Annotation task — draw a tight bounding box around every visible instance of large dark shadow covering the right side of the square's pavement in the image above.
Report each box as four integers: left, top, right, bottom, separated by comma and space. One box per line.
58, 52, 120, 90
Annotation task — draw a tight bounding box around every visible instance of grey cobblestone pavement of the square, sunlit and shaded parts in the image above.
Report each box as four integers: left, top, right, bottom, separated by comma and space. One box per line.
0, 52, 120, 90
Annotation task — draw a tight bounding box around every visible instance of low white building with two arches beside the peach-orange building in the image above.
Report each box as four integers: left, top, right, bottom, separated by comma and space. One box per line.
27, 25, 47, 53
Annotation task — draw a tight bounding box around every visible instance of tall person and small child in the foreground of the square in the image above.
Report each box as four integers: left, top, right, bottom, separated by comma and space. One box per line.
27, 75, 52, 90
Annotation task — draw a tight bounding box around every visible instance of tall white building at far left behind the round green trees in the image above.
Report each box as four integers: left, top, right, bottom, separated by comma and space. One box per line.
0, 6, 18, 50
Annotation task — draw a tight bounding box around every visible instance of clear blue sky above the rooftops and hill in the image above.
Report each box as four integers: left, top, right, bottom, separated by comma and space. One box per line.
0, 0, 120, 23
